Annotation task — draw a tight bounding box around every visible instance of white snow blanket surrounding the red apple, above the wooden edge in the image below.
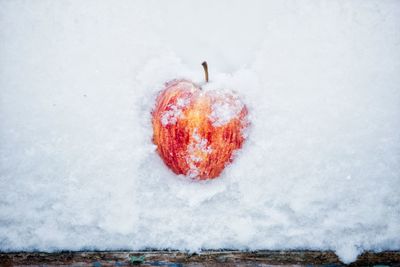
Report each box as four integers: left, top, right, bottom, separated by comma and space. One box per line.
0, 0, 400, 262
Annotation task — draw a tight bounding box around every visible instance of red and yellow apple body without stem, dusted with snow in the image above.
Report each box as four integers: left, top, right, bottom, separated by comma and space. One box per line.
152, 80, 248, 180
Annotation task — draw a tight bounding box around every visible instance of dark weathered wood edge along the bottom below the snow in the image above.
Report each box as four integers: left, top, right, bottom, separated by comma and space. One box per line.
0, 250, 400, 266
